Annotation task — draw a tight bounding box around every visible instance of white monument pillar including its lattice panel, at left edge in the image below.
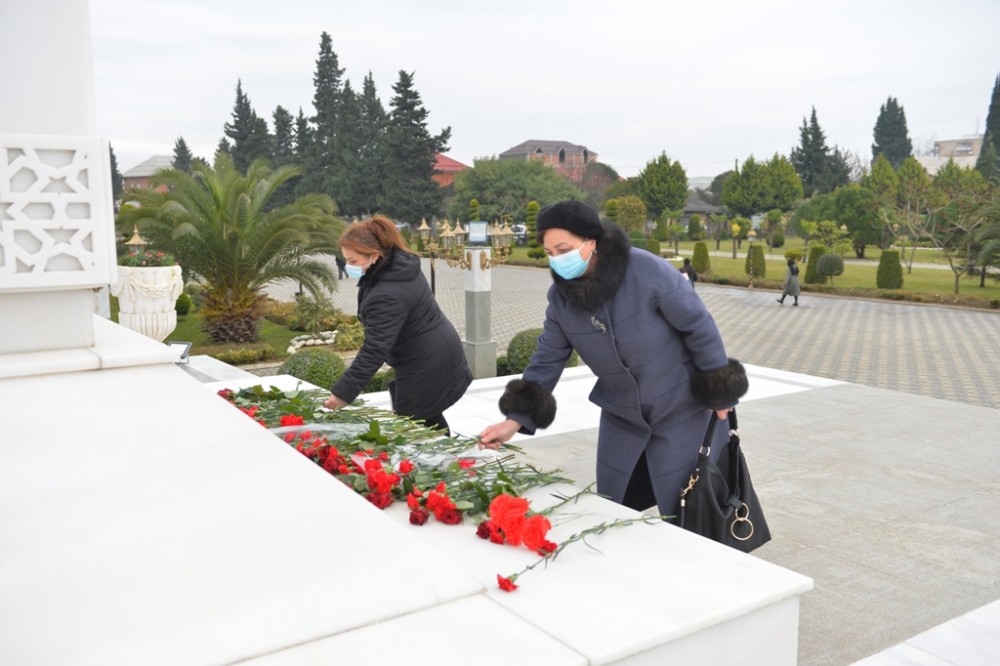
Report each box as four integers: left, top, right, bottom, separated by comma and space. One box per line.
0, 0, 116, 354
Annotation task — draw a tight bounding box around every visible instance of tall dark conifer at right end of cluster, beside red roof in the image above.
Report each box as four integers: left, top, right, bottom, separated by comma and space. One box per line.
382, 70, 451, 222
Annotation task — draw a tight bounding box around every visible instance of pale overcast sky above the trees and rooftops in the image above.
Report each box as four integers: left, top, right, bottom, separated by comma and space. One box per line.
90, 0, 1000, 177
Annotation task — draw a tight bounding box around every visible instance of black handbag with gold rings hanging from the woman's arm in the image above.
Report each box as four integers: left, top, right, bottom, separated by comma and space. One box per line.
680, 410, 771, 553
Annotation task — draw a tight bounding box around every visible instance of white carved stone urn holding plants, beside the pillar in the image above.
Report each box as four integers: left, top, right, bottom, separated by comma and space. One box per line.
111, 265, 184, 342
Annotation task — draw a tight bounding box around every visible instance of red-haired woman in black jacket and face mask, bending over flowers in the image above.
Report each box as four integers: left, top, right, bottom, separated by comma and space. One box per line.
324, 215, 472, 431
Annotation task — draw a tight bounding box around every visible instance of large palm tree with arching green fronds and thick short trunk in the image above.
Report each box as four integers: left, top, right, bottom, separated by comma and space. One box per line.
118, 152, 343, 343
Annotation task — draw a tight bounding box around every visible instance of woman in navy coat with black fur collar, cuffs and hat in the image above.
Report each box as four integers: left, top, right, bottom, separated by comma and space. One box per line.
480, 201, 748, 516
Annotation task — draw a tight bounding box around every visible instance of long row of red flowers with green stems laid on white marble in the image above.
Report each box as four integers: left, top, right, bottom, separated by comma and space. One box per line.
219, 386, 659, 592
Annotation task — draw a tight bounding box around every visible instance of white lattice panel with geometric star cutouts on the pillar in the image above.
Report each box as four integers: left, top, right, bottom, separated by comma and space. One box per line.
0, 134, 116, 292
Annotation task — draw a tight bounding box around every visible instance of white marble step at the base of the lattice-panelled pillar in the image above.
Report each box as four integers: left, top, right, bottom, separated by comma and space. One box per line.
0, 315, 180, 379
